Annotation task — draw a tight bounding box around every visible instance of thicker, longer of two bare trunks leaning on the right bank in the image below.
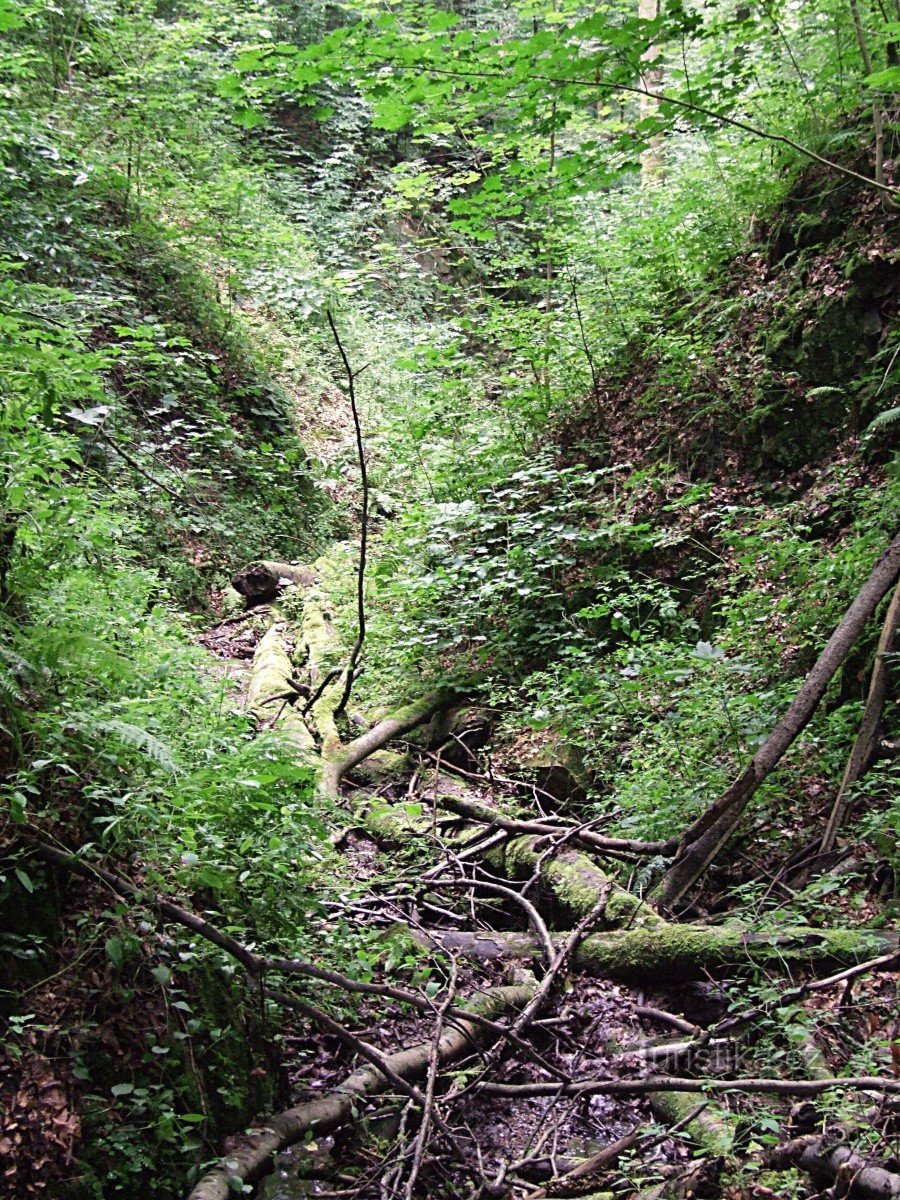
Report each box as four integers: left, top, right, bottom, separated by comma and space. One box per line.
654, 534, 900, 908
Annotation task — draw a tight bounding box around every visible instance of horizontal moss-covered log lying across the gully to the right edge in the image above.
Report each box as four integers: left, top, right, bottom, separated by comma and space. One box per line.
414, 925, 900, 984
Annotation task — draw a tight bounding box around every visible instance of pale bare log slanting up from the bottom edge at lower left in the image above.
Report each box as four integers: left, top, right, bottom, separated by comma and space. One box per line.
188, 984, 535, 1200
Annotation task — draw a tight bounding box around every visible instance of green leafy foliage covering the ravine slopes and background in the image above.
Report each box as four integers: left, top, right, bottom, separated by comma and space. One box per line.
0, 0, 900, 1196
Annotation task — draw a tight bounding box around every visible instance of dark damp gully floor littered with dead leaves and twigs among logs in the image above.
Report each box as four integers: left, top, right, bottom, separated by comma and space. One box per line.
180, 590, 900, 1200
